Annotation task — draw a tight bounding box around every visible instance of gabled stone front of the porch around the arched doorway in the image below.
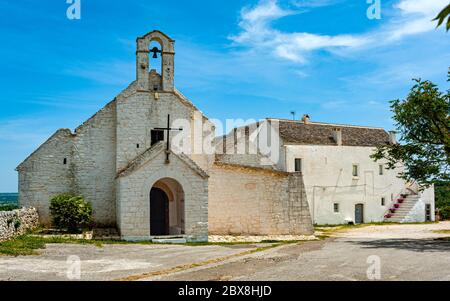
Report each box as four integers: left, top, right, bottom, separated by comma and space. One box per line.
117, 151, 208, 241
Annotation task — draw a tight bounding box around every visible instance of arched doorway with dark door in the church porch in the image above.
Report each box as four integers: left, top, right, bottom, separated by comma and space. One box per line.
150, 178, 185, 236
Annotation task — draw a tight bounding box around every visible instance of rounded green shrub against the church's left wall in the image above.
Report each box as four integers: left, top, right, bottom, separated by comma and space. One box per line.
50, 193, 92, 233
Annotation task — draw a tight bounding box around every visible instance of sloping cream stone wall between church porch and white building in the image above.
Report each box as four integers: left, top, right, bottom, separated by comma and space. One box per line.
208, 163, 313, 235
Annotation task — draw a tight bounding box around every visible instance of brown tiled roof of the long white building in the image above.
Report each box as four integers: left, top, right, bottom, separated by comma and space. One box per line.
269, 119, 389, 146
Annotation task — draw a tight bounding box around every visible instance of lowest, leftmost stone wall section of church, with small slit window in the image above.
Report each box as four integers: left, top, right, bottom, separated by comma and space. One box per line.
17, 129, 74, 224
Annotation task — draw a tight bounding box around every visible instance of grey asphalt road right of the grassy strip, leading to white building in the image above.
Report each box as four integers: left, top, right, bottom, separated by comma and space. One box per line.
154, 222, 450, 281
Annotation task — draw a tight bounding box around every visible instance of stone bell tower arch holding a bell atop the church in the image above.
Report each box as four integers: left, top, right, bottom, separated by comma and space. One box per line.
136, 30, 175, 92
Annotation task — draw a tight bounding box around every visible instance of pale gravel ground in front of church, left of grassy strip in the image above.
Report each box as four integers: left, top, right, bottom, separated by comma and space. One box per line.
0, 240, 264, 281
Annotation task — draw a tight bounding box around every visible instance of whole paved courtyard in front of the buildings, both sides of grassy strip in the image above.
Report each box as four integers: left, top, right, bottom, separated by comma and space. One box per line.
0, 222, 450, 280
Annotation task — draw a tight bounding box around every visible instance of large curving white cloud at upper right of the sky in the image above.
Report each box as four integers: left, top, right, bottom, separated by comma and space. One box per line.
230, 0, 447, 64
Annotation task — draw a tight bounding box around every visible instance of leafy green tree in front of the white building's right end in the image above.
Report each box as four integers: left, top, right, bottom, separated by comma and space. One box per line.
372, 71, 450, 187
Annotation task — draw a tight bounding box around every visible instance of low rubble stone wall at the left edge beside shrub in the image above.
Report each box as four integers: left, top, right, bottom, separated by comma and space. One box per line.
0, 208, 39, 241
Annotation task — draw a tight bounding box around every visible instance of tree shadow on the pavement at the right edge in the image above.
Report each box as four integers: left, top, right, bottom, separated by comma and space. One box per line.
353, 238, 450, 252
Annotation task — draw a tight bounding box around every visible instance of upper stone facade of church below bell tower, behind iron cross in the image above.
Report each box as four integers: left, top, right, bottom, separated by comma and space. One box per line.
116, 91, 214, 171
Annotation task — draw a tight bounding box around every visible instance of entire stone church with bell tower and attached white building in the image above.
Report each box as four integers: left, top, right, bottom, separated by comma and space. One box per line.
17, 30, 434, 241
